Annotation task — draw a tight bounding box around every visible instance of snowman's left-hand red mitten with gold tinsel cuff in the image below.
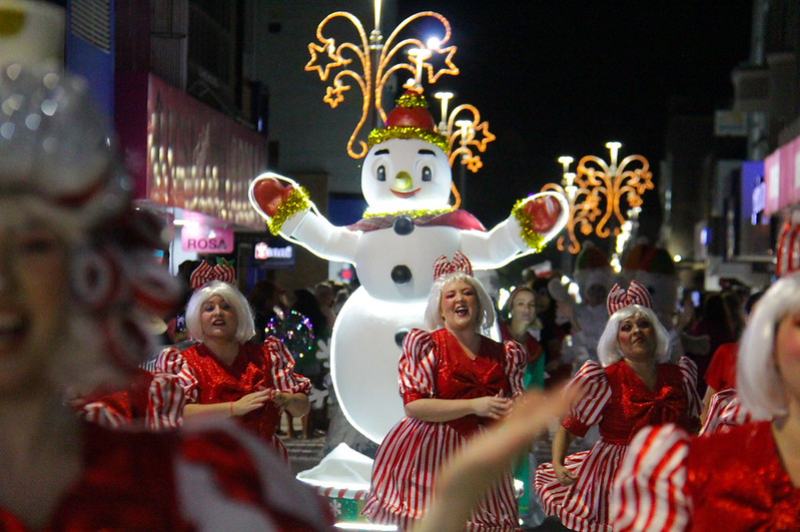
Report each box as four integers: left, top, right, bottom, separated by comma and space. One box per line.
250, 177, 311, 235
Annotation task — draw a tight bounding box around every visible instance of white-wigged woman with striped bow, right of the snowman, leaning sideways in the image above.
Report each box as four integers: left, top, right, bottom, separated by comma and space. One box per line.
534, 281, 700, 532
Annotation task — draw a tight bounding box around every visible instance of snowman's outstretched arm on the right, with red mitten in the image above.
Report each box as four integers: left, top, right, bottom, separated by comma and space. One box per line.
461, 192, 569, 269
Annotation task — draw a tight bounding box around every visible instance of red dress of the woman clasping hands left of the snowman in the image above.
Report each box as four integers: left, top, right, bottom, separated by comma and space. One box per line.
156, 338, 311, 460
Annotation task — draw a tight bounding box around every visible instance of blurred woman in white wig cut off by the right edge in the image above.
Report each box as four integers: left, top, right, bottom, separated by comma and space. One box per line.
613, 268, 800, 532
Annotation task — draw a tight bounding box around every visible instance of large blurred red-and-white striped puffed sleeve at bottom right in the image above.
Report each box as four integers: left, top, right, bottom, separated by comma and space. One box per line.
610, 425, 692, 532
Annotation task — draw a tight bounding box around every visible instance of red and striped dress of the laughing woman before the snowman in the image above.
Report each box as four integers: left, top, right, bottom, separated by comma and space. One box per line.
363, 329, 526, 531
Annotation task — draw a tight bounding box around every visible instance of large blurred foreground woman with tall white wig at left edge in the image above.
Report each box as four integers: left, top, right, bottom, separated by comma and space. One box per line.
0, 64, 328, 532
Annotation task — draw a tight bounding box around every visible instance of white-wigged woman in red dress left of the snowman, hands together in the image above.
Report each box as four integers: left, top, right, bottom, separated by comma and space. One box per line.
156, 280, 311, 461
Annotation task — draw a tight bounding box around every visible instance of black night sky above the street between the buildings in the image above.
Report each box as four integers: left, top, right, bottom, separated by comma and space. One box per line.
394, 0, 752, 270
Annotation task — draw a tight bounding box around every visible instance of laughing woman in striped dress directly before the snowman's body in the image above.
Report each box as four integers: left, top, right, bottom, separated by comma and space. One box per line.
364, 253, 526, 531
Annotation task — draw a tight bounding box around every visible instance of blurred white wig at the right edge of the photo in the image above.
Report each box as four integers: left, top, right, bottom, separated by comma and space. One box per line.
736, 272, 800, 419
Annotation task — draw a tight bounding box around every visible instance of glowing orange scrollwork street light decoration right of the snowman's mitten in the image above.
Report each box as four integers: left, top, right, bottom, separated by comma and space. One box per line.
542, 142, 654, 254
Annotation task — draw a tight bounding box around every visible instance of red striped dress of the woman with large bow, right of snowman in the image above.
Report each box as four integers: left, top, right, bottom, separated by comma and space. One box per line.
534, 357, 700, 532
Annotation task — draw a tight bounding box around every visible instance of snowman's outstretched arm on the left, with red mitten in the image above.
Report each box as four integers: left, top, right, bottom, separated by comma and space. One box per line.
249, 172, 361, 263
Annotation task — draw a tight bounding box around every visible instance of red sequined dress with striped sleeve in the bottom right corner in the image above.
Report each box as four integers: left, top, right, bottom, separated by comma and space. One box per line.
614, 421, 800, 532
